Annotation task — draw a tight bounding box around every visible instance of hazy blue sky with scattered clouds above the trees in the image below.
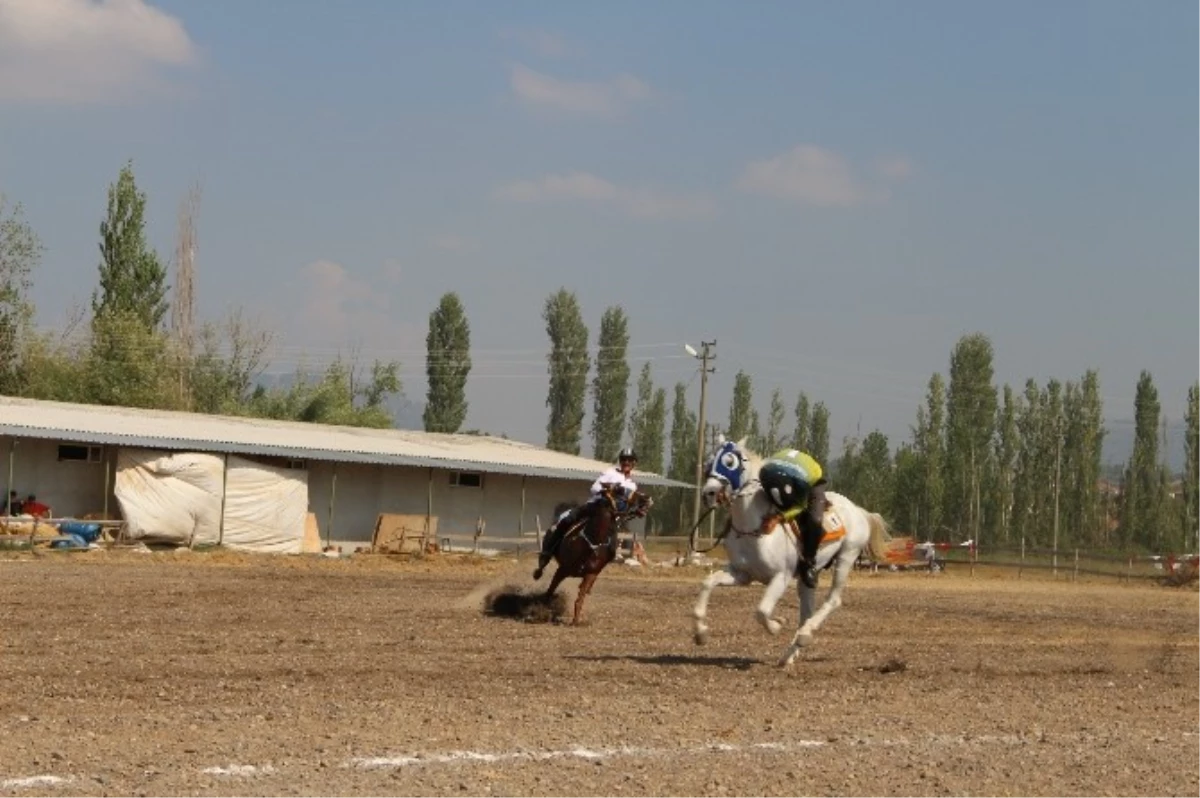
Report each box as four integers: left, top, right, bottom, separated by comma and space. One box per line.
0, 0, 1200, 463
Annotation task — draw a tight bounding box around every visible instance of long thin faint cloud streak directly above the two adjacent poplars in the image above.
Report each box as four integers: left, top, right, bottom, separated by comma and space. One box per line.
496, 172, 716, 218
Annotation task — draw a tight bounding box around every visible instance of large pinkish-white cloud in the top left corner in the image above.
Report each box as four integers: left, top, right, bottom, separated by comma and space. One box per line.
0, 0, 199, 103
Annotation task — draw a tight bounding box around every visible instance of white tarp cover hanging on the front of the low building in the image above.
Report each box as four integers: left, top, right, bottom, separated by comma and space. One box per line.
115, 449, 308, 554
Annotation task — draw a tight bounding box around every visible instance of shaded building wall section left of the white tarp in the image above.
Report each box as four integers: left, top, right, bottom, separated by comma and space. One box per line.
0, 438, 118, 517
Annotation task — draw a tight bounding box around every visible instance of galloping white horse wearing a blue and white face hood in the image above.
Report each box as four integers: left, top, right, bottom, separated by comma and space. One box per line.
692, 440, 890, 667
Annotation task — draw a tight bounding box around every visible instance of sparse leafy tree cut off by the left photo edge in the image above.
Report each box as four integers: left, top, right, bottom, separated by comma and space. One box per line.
0, 194, 42, 395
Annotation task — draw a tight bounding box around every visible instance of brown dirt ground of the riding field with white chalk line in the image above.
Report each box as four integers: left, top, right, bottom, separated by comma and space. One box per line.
0, 552, 1200, 796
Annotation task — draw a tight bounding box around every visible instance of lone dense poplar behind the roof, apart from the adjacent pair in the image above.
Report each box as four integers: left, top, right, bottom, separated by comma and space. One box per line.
424, 292, 470, 432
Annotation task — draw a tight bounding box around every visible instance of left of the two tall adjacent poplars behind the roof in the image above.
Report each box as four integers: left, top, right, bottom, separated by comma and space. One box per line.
542, 288, 592, 455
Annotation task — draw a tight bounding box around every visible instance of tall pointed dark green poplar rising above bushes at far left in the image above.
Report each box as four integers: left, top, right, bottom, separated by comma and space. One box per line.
92, 162, 167, 330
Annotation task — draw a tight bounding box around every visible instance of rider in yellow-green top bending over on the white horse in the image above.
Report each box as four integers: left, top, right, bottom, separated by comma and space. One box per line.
758, 449, 826, 588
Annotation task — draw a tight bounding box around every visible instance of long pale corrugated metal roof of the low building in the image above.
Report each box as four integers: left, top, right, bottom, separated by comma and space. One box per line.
0, 396, 694, 487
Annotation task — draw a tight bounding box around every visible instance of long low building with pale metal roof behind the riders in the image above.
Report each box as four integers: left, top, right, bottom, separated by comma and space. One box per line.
0, 397, 692, 545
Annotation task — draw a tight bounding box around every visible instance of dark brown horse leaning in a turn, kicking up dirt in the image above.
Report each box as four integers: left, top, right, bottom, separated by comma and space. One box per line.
546, 490, 650, 624
